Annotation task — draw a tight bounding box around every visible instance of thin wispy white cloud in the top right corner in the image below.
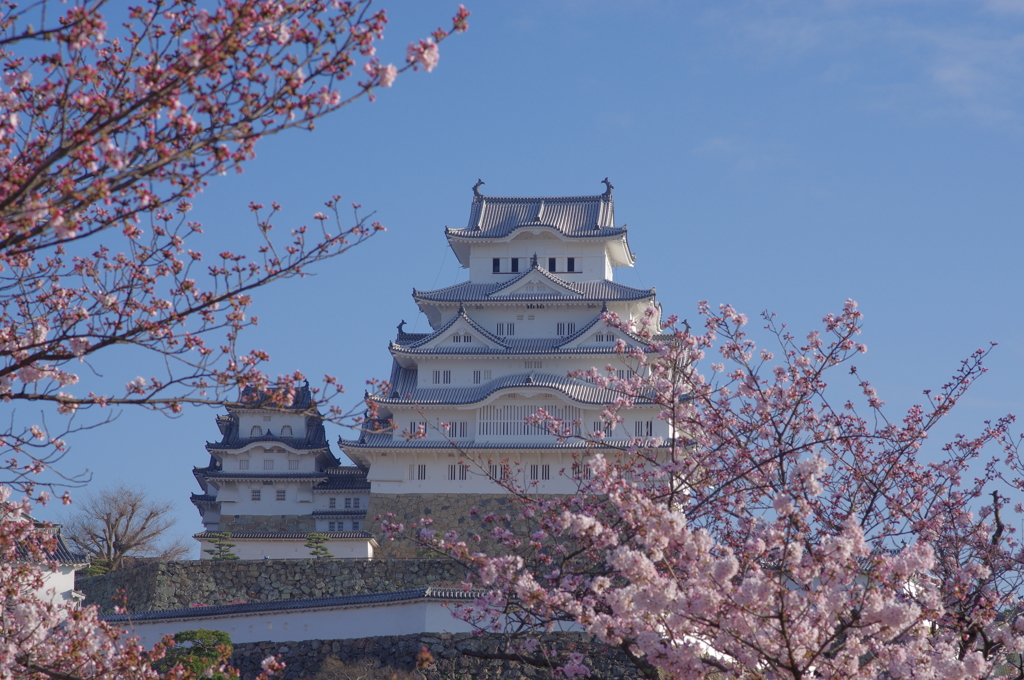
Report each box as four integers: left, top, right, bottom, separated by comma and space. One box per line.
715, 0, 1024, 130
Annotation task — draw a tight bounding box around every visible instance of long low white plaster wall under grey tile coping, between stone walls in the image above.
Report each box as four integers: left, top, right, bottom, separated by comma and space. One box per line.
117, 601, 472, 646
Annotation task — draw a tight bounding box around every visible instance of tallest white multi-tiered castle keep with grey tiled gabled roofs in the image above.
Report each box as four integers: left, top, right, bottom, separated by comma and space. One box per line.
339, 179, 669, 555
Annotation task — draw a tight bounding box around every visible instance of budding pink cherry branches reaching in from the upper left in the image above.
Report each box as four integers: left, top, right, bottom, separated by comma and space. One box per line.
0, 0, 469, 499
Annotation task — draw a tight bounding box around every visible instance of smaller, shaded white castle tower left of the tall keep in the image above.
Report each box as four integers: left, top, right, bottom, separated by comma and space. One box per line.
191, 383, 376, 559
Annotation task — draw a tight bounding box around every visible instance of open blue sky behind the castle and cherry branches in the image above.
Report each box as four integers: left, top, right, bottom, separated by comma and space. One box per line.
29, 0, 1024, 548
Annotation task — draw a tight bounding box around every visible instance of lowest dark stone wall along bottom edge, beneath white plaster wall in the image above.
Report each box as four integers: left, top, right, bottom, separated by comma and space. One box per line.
231, 633, 640, 680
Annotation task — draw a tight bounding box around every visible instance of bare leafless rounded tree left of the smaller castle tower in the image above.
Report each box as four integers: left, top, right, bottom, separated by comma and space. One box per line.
65, 484, 191, 570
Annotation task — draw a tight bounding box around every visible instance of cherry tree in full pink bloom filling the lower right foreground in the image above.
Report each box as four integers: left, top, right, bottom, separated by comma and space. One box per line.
385, 301, 1024, 679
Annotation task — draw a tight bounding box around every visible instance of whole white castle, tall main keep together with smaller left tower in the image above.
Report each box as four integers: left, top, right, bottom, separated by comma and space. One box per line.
193, 180, 669, 557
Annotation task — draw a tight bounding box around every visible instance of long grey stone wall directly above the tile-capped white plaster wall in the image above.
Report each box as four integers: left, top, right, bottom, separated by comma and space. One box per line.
75, 559, 466, 611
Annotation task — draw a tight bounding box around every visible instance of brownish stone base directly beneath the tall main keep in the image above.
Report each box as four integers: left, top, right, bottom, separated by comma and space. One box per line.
367, 494, 544, 559
